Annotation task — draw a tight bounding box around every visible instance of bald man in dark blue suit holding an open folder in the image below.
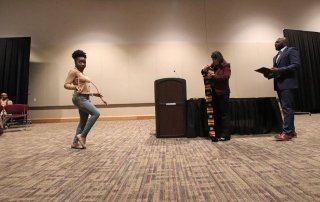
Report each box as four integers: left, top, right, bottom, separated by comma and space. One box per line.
271, 38, 300, 141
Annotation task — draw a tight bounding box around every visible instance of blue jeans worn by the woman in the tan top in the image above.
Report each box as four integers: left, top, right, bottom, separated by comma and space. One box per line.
72, 94, 100, 144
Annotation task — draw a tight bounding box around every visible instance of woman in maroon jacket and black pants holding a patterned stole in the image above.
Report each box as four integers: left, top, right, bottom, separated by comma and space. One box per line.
201, 51, 231, 141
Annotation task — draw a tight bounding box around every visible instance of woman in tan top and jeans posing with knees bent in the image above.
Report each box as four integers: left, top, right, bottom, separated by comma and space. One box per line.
64, 50, 102, 149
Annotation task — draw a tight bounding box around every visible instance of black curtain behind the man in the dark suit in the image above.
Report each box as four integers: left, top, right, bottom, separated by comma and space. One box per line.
283, 29, 320, 112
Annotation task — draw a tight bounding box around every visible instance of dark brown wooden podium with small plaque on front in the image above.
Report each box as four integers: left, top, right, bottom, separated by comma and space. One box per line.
154, 78, 187, 137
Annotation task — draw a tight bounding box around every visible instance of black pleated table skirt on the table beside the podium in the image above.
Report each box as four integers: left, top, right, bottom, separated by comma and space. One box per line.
186, 97, 282, 137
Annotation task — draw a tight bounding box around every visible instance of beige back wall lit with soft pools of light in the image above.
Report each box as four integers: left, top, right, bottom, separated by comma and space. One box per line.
0, 0, 320, 118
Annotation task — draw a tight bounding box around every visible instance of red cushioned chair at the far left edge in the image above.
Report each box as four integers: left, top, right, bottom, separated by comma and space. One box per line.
2, 104, 29, 127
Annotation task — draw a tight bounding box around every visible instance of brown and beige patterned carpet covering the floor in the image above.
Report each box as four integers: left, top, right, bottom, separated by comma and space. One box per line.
0, 114, 320, 202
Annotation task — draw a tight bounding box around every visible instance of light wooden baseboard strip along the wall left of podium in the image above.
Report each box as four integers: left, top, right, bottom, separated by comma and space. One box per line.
31, 115, 155, 123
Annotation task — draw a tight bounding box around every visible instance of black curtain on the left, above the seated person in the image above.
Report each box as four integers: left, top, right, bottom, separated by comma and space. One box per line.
0, 37, 31, 104
